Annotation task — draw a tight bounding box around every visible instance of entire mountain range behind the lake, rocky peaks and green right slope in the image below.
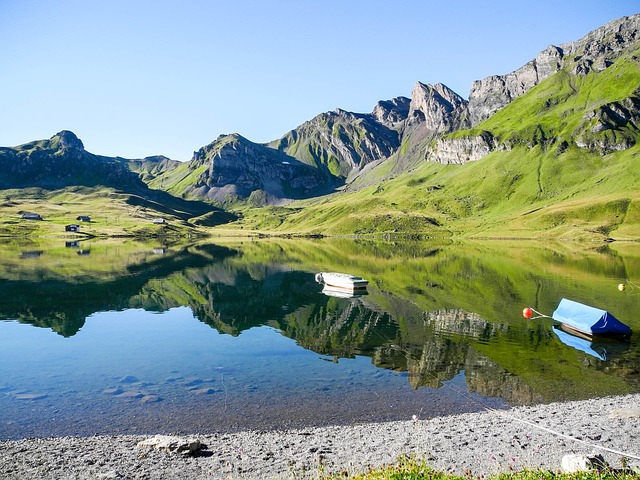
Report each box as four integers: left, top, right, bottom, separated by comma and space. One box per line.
0, 15, 640, 238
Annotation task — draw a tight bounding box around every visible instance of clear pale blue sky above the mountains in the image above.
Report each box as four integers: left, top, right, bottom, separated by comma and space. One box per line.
0, 0, 640, 161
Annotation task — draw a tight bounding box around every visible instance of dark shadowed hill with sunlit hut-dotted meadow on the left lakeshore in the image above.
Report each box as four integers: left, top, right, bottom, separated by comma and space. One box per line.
0, 130, 235, 238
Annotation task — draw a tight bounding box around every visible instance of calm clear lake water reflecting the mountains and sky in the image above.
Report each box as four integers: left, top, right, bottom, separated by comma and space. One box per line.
0, 239, 640, 439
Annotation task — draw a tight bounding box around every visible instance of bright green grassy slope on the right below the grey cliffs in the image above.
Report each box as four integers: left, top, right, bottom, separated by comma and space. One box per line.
225, 48, 640, 239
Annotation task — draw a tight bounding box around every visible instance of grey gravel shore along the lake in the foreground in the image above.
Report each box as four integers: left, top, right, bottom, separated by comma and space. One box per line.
0, 394, 640, 480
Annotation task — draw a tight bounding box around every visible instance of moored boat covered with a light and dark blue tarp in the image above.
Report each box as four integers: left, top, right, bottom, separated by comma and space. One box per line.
552, 298, 631, 335
